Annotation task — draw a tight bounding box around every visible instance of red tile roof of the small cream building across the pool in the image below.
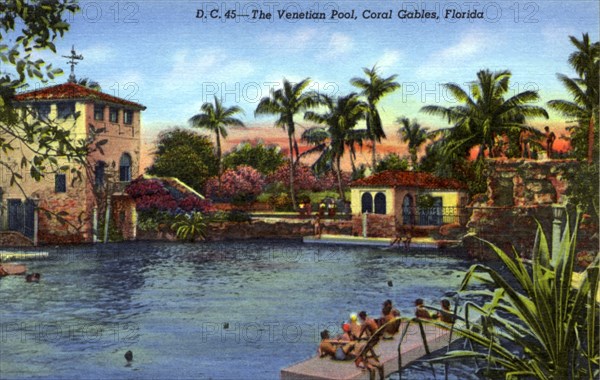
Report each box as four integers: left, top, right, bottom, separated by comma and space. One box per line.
352, 170, 467, 190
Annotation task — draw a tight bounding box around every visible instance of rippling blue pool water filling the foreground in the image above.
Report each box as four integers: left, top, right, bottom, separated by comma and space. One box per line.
0, 241, 478, 379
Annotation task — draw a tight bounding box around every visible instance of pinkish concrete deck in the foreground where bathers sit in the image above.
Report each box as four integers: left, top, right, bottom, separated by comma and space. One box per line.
280, 322, 456, 380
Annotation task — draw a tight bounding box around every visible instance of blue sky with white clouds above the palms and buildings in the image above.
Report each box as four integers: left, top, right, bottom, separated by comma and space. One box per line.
12, 0, 600, 147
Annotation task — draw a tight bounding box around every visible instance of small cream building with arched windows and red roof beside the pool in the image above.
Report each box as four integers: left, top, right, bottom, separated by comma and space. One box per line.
350, 170, 468, 236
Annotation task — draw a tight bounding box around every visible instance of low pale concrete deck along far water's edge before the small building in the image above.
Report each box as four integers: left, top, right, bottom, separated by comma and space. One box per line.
302, 234, 460, 250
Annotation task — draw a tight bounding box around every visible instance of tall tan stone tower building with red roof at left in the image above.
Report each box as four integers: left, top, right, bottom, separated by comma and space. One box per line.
0, 82, 145, 244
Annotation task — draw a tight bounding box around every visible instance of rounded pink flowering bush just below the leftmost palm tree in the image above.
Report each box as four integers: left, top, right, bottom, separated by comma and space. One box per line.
206, 165, 265, 202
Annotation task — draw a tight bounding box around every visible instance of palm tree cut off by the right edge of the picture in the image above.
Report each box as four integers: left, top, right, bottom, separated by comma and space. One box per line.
548, 33, 600, 163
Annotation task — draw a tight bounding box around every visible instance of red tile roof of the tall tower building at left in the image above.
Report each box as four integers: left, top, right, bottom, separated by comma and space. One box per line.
15, 82, 146, 110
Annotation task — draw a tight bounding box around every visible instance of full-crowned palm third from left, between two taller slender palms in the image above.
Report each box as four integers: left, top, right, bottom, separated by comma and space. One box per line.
303, 93, 369, 200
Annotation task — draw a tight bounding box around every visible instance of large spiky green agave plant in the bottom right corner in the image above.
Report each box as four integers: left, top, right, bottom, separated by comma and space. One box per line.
430, 215, 600, 380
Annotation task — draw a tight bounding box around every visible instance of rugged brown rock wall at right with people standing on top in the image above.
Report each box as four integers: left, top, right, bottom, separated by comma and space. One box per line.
463, 159, 579, 257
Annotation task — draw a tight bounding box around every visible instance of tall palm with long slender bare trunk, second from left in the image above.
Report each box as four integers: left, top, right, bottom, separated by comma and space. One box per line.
254, 78, 318, 209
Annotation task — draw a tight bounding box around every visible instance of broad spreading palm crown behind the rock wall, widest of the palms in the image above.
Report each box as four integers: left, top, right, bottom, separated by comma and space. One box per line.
421, 69, 548, 159
